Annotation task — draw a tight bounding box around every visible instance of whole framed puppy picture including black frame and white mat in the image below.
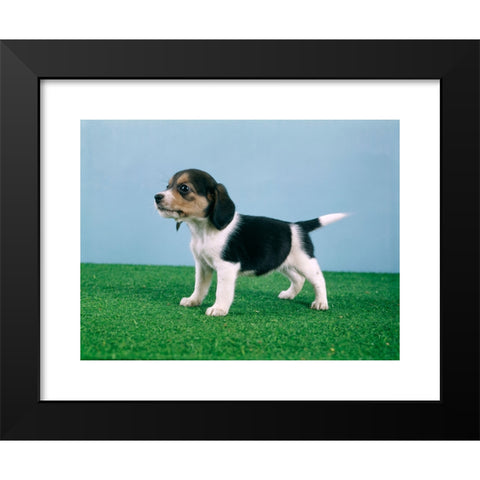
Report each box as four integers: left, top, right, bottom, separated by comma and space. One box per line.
0, 41, 480, 440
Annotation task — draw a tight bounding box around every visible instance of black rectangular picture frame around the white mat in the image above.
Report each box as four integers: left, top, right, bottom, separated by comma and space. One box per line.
0, 40, 480, 440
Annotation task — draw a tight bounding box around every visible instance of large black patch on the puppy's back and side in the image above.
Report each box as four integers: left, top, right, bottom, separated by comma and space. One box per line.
222, 215, 292, 275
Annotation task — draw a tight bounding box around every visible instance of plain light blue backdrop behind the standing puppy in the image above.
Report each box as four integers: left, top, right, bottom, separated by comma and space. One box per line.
81, 120, 399, 272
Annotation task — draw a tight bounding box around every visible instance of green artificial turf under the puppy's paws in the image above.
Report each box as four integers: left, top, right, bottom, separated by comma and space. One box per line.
81, 264, 399, 360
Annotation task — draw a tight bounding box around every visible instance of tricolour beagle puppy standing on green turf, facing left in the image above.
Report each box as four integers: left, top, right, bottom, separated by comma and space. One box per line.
154, 169, 346, 316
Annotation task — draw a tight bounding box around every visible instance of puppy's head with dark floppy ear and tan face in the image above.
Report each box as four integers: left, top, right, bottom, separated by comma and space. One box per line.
155, 169, 235, 230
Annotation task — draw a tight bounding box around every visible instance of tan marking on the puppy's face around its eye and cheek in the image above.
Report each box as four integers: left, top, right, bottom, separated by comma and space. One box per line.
163, 173, 209, 218
